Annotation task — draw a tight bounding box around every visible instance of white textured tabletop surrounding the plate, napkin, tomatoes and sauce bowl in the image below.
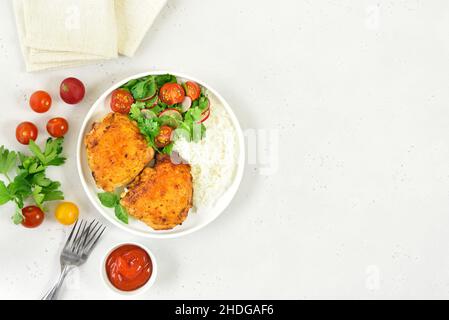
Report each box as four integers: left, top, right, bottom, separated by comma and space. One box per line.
0, 0, 449, 299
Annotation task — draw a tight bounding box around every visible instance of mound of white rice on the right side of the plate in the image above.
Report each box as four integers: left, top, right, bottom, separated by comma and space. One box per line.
174, 97, 238, 210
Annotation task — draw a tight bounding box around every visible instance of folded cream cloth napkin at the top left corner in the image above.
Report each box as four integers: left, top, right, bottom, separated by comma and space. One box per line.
14, 0, 167, 72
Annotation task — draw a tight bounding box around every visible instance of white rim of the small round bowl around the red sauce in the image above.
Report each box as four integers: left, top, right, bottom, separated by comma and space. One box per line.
100, 242, 157, 297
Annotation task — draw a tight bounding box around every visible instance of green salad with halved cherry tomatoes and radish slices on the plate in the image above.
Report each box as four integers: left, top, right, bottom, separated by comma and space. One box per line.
111, 74, 210, 155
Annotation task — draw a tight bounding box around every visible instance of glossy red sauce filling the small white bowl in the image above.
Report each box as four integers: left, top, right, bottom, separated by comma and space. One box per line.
106, 244, 153, 291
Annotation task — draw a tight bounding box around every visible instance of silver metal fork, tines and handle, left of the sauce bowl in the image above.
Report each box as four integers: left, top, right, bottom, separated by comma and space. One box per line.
42, 220, 106, 300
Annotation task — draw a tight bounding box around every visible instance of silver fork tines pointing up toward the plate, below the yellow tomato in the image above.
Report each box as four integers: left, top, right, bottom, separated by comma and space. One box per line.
64, 220, 106, 255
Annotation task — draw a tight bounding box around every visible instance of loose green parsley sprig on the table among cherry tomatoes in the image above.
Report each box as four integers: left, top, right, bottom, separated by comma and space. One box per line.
0, 138, 66, 224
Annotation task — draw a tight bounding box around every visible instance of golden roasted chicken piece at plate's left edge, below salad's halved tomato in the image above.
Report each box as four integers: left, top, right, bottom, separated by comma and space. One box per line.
84, 113, 154, 192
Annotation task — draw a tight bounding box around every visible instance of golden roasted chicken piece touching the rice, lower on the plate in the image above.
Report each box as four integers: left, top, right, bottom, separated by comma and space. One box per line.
121, 156, 193, 230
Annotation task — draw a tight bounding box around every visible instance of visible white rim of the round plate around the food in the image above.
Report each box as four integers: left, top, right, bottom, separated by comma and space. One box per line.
77, 71, 245, 238
